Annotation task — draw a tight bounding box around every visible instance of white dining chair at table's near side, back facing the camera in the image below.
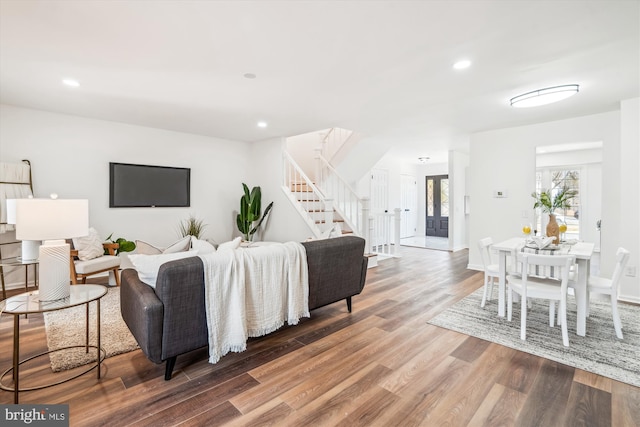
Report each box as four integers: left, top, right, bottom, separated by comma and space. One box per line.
507, 253, 575, 347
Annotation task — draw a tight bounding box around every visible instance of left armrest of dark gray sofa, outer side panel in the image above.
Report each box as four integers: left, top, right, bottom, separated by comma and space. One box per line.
120, 268, 164, 363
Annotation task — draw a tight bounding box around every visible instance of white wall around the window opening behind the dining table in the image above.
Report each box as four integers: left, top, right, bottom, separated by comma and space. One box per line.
469, 108, 640, 300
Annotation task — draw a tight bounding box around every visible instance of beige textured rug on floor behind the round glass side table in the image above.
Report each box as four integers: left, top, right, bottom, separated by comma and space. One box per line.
44, 287, 138, 372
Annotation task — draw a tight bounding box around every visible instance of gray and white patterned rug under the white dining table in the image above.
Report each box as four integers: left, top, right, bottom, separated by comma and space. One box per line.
428, 288, 640, 387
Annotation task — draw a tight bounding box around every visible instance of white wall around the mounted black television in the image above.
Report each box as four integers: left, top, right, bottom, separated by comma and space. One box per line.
0, 105, 252, 283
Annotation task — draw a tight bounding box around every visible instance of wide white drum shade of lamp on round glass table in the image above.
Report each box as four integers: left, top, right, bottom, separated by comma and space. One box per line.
16, 199, 89, 240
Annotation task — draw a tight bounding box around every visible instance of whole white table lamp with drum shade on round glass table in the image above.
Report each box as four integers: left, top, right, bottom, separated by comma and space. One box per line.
16, 195, 89, 301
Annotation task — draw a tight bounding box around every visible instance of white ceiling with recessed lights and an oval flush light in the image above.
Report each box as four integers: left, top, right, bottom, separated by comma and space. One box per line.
0, 0, 640, 163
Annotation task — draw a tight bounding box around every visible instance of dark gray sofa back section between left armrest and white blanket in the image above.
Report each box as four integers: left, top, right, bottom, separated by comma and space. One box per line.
155, 256, 209, 360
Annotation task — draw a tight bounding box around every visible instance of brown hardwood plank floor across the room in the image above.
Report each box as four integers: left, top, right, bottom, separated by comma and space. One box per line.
0, 247, 640, 427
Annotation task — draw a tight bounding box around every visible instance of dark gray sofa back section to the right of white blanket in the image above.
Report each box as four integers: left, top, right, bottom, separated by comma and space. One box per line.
303, 236, 367, 310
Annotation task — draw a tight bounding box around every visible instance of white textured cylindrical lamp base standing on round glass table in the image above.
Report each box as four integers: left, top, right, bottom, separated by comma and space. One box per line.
39, 240, 71, 301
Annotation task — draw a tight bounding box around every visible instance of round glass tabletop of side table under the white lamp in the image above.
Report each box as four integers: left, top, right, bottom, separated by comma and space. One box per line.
0, 285, 107, 315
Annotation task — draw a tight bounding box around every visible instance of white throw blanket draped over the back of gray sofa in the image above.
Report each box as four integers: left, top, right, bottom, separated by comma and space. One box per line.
199, 242, 309, 363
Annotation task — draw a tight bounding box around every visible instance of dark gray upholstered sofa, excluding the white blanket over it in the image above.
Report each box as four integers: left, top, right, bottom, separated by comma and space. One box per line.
120, 236, 367, 380
